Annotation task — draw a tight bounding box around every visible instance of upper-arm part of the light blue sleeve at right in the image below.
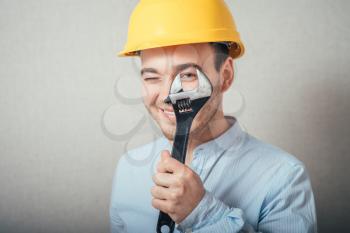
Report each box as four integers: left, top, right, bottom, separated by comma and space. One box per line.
259, 164, 317, 233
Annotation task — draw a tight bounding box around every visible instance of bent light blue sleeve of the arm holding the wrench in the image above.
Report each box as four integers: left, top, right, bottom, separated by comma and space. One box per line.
176, 165, 317, 233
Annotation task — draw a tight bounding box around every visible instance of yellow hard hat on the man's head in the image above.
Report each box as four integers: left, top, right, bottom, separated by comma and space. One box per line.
118, 0, 244, 58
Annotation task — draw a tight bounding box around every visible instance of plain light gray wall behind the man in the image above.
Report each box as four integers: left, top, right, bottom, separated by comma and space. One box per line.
0, 0, 350, 233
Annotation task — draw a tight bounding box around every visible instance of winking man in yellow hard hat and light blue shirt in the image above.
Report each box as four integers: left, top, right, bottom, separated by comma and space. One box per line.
110, 0, 316, 233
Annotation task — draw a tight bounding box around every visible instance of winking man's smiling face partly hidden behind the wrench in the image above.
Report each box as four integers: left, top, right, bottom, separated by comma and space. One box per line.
140, 43, 226, 141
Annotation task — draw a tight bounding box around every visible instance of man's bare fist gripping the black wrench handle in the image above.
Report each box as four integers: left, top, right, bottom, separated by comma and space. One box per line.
151, 150, 205, 223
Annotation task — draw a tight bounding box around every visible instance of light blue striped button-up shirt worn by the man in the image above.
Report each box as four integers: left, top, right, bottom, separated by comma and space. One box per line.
110, 117, 317, 233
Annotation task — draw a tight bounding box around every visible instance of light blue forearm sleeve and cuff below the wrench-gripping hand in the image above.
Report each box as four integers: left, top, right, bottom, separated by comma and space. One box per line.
176, 190, 244, 232
